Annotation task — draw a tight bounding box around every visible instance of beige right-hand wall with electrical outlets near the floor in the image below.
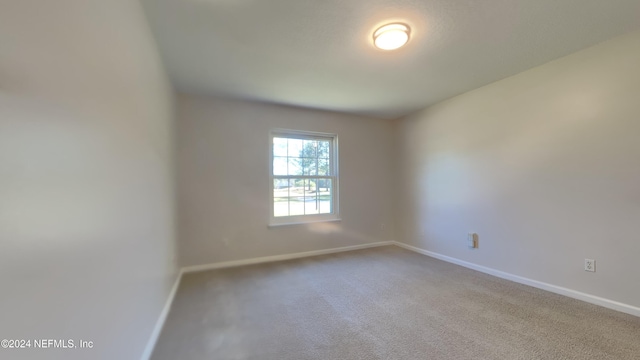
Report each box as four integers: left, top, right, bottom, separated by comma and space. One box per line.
395, 32, 640, 306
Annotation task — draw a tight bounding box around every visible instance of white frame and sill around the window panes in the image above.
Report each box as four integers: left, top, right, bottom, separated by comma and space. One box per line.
269, 129, 340, 226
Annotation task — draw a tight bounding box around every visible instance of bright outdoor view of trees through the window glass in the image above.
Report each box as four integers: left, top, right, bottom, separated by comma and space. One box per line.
273, 137, 333, 217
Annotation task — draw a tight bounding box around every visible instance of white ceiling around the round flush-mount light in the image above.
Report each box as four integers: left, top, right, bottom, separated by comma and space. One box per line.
143, 0, 640, 118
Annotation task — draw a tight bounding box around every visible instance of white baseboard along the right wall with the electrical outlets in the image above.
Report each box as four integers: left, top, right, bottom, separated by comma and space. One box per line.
393, 241, 640, 317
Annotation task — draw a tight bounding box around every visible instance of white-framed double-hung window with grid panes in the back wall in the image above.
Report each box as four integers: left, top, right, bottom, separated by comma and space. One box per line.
269, 130, 338, 225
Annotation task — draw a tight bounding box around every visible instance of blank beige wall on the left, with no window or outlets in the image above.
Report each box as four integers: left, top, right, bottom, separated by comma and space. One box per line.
0, 0, 177, 360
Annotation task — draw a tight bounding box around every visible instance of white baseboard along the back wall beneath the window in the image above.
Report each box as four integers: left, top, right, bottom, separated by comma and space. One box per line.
182, 241, 394, 273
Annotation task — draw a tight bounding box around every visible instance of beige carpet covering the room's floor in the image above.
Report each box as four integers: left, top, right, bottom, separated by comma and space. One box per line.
152, 246, 640, 360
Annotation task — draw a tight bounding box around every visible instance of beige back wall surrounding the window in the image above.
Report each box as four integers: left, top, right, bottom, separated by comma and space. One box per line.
177, 95, 394, 266
